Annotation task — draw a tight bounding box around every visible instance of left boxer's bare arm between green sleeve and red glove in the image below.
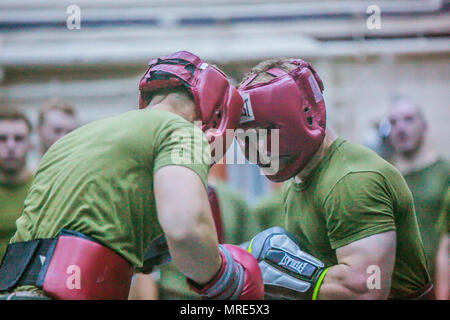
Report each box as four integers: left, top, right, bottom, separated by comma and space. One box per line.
154, 166, 221, 284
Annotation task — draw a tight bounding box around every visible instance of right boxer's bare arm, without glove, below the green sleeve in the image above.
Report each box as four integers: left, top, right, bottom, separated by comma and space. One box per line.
318, 231, 396, 299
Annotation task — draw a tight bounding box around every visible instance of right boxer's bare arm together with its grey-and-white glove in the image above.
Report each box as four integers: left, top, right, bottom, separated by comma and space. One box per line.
247, 227, 396, 300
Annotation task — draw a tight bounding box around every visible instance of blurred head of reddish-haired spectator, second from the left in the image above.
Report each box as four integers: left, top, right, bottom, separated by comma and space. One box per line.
37, 98, 78, 156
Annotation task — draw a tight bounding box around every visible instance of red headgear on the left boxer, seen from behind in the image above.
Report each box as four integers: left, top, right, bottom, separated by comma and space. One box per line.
139, 51, 243, 161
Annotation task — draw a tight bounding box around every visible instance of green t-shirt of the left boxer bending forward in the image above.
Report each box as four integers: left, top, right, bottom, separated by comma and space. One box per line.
11, 109, 210, 267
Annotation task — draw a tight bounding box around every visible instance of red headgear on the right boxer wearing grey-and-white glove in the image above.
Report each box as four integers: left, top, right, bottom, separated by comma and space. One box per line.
238, 59, 326, 182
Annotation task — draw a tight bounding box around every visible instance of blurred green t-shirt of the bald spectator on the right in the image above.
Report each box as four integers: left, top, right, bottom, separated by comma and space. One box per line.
404, 159, 450, 275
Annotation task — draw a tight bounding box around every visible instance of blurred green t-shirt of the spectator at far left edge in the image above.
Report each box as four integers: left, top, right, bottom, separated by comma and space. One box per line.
0, 174, 33, 261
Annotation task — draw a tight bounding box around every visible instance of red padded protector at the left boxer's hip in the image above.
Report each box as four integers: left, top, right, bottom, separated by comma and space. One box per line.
43, 235, 133, 300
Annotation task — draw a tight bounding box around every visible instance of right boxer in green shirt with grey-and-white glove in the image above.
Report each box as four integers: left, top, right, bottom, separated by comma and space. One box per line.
239, 59, 432, 299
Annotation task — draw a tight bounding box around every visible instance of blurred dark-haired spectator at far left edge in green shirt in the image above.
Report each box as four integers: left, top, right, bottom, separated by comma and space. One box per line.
0, 107, 33, 261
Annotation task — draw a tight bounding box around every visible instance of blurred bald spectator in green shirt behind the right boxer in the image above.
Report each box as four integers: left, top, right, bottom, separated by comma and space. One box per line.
389, 97, 449, 299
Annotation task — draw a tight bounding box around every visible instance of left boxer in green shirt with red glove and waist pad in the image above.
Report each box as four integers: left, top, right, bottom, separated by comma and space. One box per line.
0, 51, 263, 299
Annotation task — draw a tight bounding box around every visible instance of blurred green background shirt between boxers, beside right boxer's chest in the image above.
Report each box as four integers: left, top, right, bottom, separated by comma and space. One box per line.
252, 188, 284, 232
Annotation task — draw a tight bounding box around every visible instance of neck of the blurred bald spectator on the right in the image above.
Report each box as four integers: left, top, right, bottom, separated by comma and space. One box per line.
392, 143, 438, 174
